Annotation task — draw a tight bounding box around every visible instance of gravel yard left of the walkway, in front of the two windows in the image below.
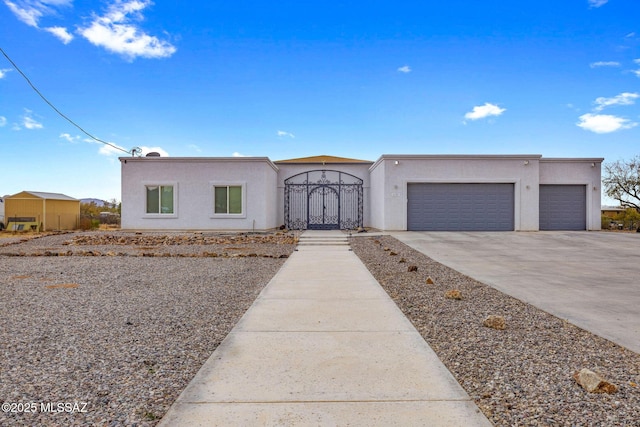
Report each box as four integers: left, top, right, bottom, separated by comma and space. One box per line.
0, 232, 295, 426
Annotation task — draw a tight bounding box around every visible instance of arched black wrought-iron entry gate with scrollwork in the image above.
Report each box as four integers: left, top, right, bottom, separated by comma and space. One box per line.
284, 170, 363, 230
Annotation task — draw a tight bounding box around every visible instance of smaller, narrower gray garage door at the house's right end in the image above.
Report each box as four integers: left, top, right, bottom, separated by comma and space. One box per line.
540, 185, 587, 230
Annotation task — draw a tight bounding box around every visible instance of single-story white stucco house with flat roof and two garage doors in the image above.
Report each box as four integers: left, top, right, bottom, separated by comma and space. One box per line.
120, 154, 603, 231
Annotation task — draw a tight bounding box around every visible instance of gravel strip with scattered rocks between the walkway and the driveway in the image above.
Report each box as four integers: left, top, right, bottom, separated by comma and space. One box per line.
351, 236, 640, 426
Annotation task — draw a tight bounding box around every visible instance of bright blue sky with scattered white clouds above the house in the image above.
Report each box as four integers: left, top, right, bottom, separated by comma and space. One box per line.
0, 0, 640, 200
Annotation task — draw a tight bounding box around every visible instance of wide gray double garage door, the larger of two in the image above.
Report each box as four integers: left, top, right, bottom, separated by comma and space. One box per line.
407, 183, 514, 231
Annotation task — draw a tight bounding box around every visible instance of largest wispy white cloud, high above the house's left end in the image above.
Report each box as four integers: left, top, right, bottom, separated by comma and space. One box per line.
79, 0, 176, 60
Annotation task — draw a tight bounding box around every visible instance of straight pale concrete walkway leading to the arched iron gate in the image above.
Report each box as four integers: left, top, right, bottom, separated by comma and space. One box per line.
160, 231, 491, 426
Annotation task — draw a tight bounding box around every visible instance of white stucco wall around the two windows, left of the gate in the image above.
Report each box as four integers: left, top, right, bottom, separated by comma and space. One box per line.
120, 157, 279, 230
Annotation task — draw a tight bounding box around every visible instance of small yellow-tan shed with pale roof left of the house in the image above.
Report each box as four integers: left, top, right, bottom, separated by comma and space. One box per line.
4, 191, 80, 231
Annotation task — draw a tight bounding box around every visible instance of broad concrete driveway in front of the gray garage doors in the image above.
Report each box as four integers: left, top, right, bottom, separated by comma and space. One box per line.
391, 231, 640, 353
